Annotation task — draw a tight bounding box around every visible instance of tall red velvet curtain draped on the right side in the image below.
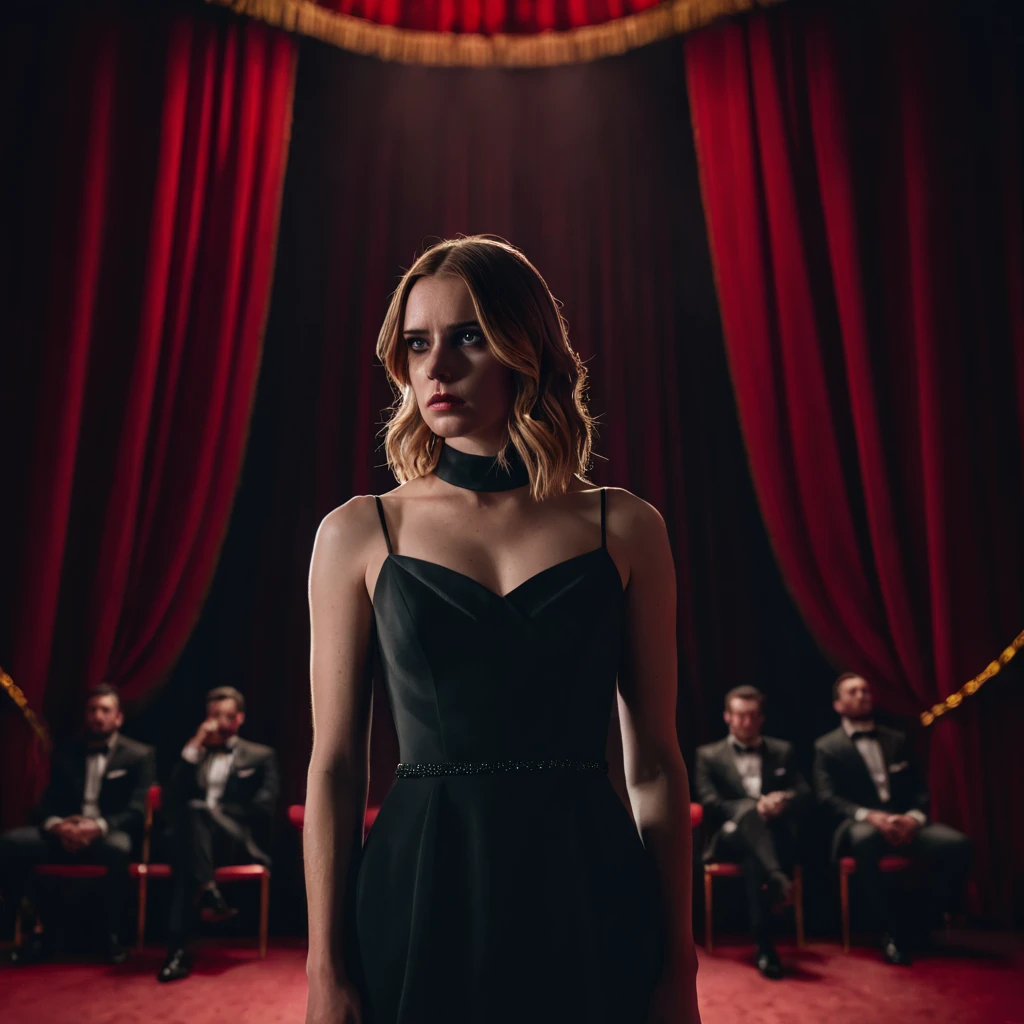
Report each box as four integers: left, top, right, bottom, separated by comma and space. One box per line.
685, 3, 1024, 908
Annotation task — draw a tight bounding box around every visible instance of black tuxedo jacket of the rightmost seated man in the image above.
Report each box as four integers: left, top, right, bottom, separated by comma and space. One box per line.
814, 725, 929, 856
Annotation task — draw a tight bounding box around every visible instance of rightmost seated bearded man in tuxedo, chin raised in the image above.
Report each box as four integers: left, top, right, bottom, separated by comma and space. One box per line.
814, 672, 973, 965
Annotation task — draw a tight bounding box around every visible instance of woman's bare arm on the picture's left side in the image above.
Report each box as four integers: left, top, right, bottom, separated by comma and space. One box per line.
302, 497, 377, 1024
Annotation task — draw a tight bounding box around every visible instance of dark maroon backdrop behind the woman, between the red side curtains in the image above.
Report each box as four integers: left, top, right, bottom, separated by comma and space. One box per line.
128, 40, 834, 931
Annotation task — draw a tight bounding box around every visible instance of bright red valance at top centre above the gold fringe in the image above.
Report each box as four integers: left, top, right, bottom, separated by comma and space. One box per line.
319, 0, 660, 36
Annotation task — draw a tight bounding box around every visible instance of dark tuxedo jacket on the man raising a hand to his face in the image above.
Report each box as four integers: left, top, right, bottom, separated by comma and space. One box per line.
167, 736, 281, 863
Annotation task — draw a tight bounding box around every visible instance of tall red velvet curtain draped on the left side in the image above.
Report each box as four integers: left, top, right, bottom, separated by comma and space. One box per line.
0, 5, 295, 821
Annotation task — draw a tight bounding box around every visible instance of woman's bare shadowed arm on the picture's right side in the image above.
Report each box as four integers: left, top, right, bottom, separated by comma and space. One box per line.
612, 492, 699, 1024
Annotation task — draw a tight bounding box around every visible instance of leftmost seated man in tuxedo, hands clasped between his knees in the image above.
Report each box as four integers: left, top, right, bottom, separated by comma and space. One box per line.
0, 683, 157, 964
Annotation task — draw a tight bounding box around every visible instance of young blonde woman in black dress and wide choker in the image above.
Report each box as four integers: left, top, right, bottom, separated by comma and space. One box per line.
304, 236, 699, 1024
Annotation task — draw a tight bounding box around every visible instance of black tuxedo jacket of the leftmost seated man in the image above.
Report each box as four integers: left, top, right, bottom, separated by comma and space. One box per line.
33, 733, 157, 842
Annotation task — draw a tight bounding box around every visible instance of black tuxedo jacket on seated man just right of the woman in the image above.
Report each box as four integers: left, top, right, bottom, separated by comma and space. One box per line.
693, 736, 812, 850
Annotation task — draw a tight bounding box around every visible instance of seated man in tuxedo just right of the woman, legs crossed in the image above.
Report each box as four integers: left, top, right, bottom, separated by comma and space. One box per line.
694, 686, 811, 979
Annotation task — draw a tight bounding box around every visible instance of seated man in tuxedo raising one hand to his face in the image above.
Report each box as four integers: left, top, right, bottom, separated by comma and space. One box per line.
157, 686, 281, 981
